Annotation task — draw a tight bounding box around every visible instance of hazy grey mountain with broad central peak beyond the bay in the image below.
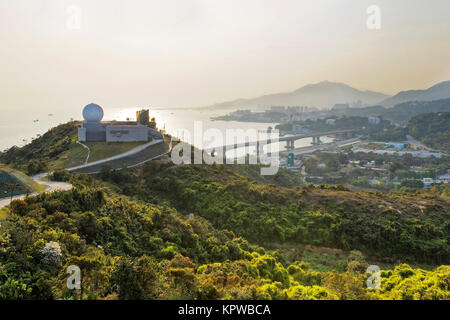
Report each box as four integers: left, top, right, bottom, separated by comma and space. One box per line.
207, 81, 388, 109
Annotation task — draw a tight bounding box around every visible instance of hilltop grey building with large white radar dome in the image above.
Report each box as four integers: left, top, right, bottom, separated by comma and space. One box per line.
78, 103, 163, 142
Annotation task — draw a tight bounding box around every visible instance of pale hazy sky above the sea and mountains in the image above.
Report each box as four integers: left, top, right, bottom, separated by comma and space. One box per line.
0, 0, 450, 110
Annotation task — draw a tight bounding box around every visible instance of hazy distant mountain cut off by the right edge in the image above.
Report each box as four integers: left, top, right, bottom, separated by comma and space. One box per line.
379, 81, 450, 107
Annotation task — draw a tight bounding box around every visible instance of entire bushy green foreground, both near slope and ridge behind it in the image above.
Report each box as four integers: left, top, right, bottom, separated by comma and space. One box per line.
0, 123, 450, 300
